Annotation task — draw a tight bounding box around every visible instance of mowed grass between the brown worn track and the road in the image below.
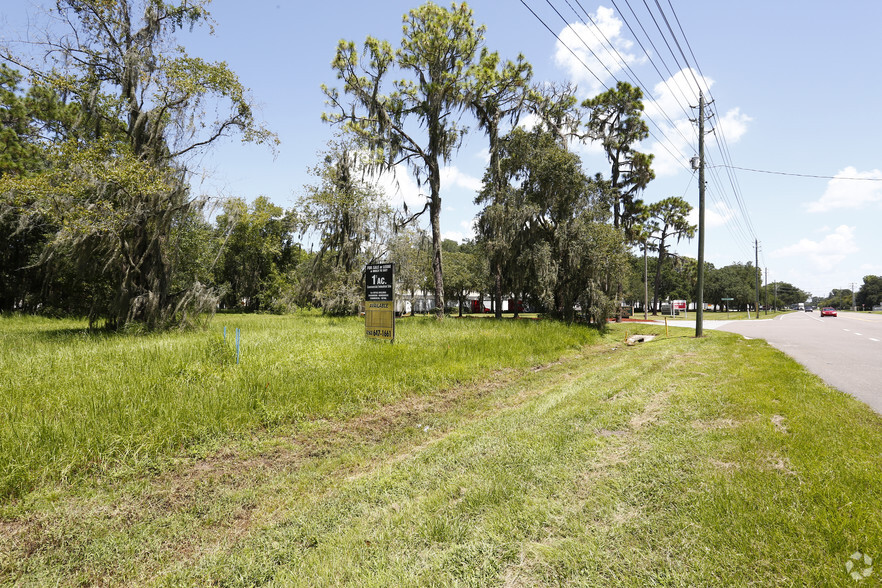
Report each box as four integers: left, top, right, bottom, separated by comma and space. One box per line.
170, 330, 882, 586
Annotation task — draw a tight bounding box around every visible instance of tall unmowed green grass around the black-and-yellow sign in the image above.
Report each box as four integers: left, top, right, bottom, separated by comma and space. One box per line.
0, 313, 595, 499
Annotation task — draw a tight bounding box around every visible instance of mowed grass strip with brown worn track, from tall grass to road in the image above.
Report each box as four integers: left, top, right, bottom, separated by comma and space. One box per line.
0, 323, 882, 586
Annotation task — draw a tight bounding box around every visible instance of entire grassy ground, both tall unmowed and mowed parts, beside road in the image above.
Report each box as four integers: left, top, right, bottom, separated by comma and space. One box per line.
0, 316, 882, 586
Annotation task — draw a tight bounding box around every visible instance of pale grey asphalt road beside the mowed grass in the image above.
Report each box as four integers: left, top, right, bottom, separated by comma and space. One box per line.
716, 310, 882, 414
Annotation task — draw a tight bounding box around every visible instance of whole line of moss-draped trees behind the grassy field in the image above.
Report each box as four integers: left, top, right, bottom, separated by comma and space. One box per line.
0, 0, 820, 329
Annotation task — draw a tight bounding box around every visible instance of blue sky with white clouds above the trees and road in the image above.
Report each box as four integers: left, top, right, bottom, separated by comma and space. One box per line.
6, 0, 882, 296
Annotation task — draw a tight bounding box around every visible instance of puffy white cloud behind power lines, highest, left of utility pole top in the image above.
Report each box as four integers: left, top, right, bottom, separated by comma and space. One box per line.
554, 6, 640, 94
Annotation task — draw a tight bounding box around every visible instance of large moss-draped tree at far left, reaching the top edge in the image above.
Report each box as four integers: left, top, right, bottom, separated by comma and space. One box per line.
0, 0, 276, 328
